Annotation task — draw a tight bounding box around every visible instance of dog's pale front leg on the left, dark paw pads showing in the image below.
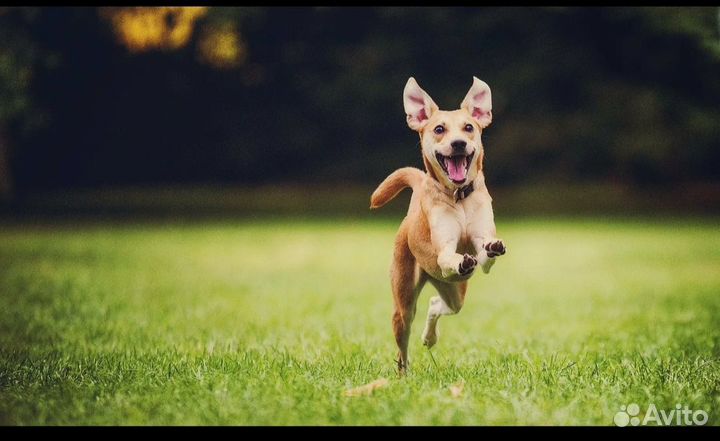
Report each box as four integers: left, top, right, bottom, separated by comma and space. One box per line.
429, 208, 477, 278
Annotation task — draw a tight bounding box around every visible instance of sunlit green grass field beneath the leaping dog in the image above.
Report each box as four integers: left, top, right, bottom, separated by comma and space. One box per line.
0, 216, 720, 425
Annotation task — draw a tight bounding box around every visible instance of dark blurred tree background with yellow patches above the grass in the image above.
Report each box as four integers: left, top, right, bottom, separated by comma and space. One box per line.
0, 7, 720, 215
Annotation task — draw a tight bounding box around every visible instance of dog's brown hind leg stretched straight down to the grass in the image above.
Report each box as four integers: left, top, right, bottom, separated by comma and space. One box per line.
390, 229, 428, 374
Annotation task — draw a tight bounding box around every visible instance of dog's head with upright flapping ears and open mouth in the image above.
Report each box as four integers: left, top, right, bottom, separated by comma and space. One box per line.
403, 77, 492, 189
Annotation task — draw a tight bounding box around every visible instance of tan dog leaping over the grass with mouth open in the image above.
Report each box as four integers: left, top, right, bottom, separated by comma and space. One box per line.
370, 77, 505, 373
